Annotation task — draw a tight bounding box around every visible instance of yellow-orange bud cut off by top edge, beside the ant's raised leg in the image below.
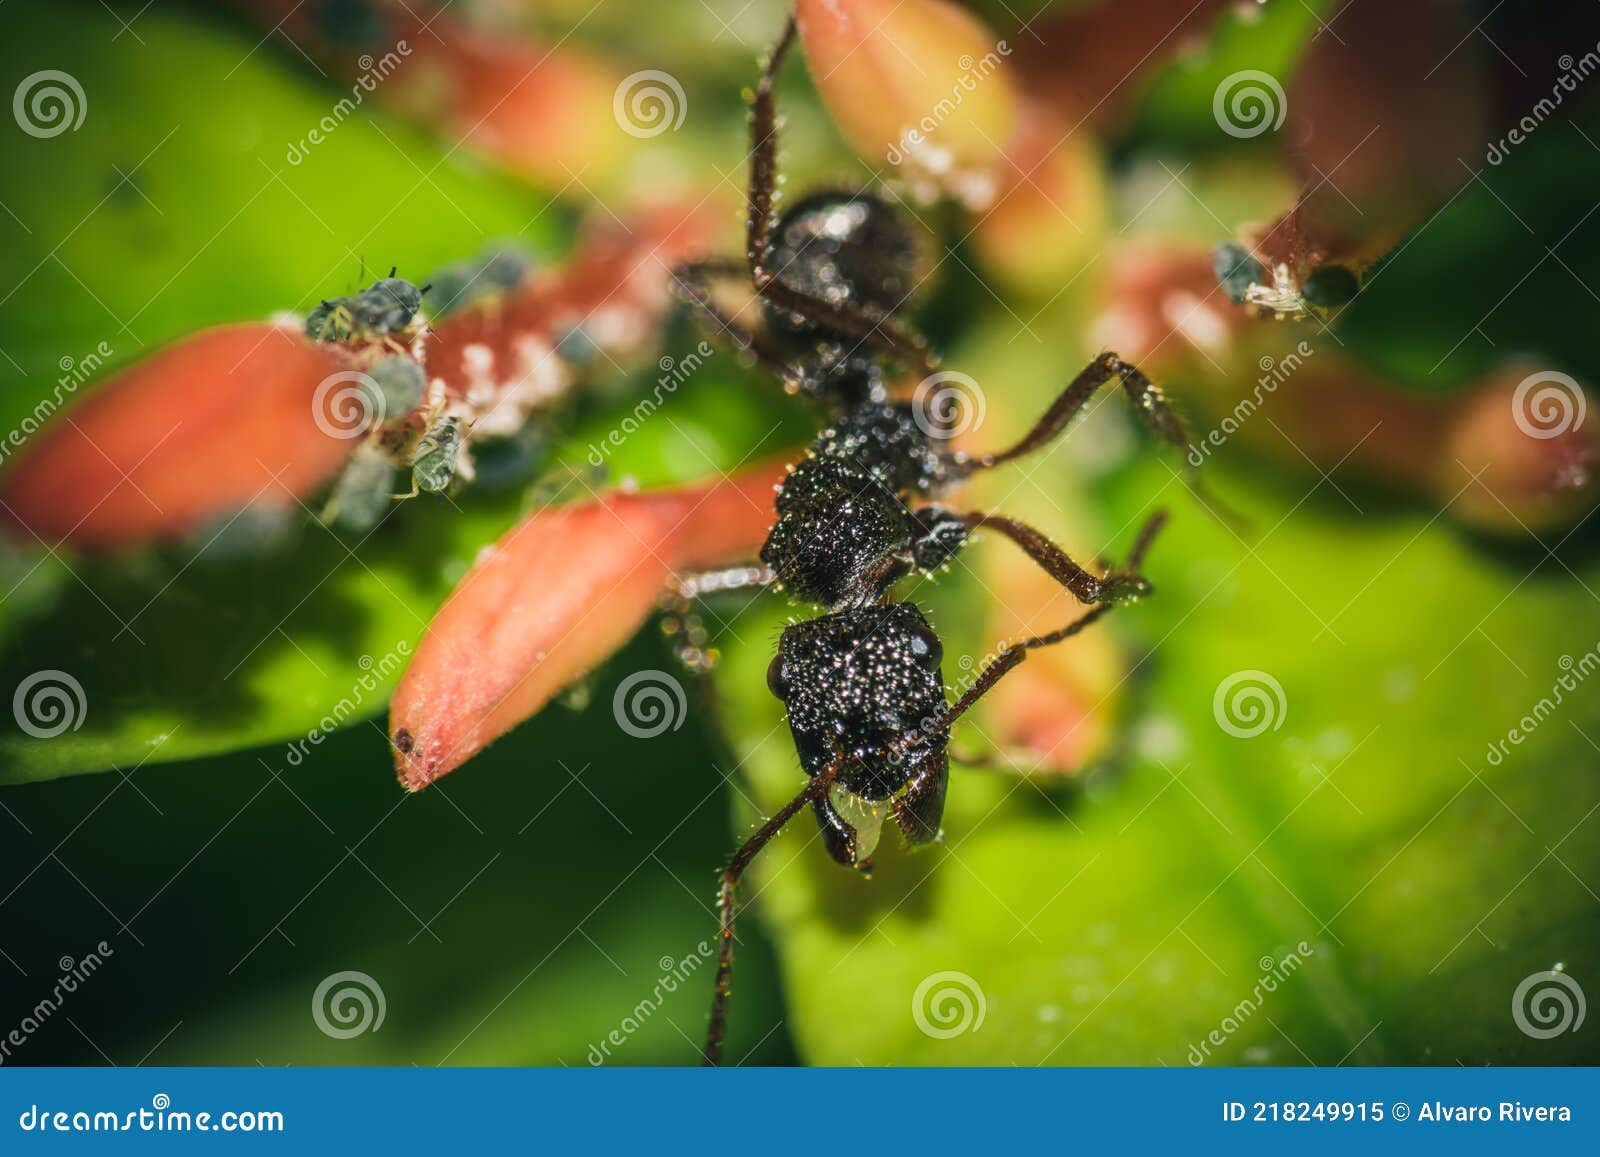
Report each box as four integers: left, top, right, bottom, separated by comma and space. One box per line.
795, 0, 1018, 210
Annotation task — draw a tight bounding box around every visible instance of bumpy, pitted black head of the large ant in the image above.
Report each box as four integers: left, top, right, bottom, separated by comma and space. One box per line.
766, 603, 949, 800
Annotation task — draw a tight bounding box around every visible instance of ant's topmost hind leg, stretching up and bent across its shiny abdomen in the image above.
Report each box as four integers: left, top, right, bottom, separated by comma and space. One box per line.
744, 16, 938, 374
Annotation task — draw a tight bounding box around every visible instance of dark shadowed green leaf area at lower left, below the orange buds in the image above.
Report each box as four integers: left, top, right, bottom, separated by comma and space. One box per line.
0, 639, 794, 1067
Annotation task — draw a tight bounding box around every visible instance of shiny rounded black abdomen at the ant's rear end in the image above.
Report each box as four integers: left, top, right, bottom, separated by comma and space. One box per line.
766, 189, 920, 349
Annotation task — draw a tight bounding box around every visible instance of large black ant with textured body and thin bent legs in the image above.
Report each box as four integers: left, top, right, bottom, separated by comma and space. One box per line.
675, 18, 1189, 1064
